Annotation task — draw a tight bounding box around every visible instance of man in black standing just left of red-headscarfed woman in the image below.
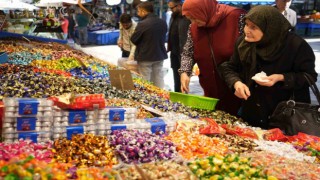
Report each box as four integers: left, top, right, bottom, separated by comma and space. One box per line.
168, 0, 191, 92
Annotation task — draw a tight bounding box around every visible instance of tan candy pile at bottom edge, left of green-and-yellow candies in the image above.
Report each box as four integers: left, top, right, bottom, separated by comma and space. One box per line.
119, 161, 197, 180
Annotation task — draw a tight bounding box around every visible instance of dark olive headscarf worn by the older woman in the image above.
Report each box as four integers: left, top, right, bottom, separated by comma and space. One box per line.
238, 6, 291, 82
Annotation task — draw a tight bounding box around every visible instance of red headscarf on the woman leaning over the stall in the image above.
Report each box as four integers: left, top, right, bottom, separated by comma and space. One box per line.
182, 0, 236, 27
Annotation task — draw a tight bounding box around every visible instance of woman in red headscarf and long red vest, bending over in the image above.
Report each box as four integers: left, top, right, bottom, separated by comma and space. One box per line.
179, 0, 245, 115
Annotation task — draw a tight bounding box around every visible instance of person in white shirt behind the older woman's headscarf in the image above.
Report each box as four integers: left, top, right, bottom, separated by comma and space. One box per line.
275, 0, 297, 31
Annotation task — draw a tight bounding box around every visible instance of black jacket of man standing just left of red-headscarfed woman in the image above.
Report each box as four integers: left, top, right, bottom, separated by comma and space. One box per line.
168, 15, 191, 69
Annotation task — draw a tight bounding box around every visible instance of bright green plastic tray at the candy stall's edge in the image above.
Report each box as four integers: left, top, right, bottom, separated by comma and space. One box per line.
170, 92, 219, 110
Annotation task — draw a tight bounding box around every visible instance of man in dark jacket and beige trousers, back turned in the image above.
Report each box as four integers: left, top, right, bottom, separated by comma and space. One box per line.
131, 2, 168, 88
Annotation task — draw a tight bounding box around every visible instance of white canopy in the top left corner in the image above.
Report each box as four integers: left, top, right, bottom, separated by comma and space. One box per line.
0, 0, 39, 11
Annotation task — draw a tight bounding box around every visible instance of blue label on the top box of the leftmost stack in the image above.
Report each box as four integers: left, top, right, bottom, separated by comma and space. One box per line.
19, 99, 39, 115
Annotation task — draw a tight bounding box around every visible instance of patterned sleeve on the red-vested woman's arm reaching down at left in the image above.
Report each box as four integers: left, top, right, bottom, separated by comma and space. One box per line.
178, 27, 195, 76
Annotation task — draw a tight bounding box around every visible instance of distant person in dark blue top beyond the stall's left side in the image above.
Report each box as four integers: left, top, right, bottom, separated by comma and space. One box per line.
76, 9, 89, 46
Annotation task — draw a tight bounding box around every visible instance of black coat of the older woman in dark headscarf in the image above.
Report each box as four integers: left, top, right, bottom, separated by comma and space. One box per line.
219, 33, 317, 128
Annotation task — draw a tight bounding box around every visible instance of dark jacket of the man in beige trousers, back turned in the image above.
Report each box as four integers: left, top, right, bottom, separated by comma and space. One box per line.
131, 14, 168, 61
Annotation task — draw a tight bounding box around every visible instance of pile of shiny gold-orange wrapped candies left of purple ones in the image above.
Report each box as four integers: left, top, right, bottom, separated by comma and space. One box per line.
53, 134, 119, 167
